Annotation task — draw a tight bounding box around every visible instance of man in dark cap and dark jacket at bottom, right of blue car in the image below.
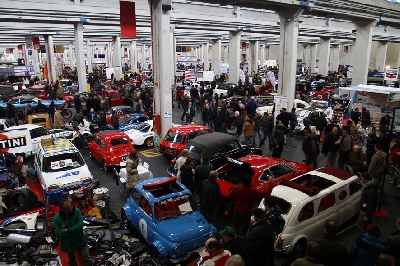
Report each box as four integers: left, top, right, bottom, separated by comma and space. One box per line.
219, 226, 258, 265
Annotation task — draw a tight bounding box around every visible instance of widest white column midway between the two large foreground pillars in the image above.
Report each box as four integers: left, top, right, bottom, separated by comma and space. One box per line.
229, 31, 242, 83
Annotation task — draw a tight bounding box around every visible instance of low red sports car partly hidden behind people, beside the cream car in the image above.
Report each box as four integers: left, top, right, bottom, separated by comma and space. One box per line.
217, 154, 314, 199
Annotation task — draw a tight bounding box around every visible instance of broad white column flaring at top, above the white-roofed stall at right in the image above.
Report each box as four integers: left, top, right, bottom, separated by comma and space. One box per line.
351, 19, 376, 86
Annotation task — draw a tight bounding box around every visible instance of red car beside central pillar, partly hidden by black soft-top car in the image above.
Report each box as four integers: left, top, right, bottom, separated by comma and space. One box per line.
160, 125, 212, 158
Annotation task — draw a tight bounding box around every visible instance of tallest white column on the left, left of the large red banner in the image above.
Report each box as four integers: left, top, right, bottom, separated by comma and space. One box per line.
74, 23, 87, 92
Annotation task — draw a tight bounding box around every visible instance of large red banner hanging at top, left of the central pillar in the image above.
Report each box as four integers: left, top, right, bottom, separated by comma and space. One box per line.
119, 1, 136, 38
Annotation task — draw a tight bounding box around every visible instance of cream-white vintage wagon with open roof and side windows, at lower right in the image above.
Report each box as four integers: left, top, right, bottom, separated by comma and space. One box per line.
270, 167, 361, 258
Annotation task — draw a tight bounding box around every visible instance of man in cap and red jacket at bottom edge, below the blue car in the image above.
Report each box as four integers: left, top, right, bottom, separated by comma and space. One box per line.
198, 237, 231, 266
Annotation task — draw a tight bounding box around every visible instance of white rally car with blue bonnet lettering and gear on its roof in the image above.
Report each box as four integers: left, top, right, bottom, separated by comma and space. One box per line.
34, 138, 93, 203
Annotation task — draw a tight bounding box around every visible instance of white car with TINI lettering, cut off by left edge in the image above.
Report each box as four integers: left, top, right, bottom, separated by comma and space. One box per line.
0, 124, 49, 157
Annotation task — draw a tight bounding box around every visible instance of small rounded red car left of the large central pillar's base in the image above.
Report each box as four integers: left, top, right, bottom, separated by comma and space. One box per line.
89, 130, 133, 172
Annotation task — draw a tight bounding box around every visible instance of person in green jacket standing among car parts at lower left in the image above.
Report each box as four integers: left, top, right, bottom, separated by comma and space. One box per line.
54, 200, 92, 266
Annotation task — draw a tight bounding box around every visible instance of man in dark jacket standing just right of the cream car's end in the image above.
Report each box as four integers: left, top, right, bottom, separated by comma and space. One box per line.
356, 173, 379, 234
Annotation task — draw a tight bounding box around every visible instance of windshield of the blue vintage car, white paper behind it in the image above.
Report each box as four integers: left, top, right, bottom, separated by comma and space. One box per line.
154, 194, 197, 220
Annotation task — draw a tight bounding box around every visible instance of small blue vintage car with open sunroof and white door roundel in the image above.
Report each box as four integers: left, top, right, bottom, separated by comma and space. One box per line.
121, 177, 217, 264
